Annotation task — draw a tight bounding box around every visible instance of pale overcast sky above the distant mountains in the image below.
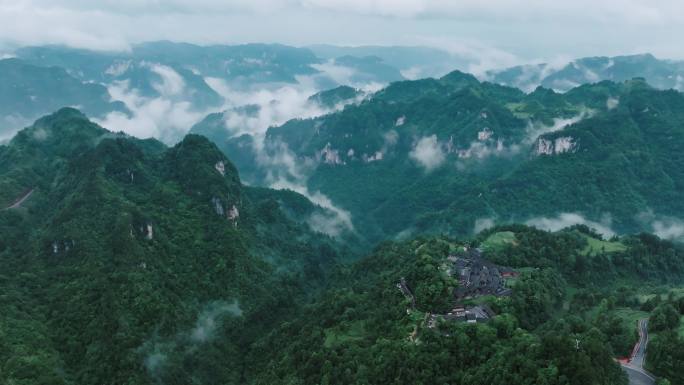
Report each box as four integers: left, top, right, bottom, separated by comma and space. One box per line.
0, 0, 684, 65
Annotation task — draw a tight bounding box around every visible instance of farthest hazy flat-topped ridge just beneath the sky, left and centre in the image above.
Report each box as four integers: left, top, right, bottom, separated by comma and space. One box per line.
15, 41, 408, 89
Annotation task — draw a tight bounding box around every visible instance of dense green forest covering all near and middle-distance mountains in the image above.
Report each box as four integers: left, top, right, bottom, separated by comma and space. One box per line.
0, 72, 684, 385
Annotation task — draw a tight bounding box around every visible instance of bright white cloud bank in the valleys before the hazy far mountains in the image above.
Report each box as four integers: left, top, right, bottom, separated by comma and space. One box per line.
97, 62, 368, 143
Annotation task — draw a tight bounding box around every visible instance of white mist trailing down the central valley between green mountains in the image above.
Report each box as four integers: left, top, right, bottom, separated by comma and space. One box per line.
196, 68, 380, 237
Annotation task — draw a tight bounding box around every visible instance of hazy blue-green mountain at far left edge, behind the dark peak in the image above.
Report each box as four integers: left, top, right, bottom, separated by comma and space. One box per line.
0, 59, 129, 137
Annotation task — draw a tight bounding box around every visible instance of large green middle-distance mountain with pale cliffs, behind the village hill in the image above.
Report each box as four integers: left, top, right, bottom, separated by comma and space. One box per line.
215, 72, 684, 241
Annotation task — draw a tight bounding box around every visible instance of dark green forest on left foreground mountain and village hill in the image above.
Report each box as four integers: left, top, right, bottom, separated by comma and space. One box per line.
0, 109, 684, 385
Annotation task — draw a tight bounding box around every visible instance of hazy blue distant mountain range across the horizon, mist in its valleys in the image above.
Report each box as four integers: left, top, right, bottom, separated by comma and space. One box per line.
0, 41, 684, 142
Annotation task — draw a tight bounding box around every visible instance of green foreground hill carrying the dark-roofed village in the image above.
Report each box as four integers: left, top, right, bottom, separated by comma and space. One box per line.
249, 226, 684, 384
